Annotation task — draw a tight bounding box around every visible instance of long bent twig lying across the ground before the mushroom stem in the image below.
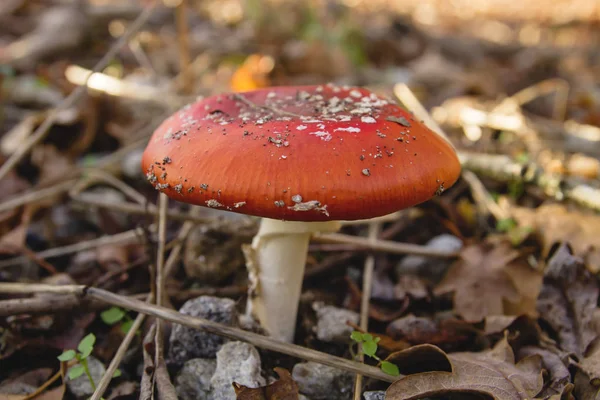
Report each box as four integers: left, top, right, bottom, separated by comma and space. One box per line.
0, 283, 398, 382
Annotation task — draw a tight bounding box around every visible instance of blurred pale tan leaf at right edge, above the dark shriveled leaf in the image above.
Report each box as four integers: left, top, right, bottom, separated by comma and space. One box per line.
511, 204, 600, 273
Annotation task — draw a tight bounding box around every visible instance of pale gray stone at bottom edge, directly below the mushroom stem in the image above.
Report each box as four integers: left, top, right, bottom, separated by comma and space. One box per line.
211, 342, 266, 400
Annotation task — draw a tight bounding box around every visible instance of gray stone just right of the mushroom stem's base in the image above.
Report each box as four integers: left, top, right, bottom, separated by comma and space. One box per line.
313, 303, 359, 343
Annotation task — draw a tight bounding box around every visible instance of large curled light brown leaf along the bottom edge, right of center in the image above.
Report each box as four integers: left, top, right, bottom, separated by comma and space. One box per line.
385, 338, 544, 400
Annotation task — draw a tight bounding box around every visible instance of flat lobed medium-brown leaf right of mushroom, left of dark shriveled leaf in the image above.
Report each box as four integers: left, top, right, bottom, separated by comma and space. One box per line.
434, 239, 542, 321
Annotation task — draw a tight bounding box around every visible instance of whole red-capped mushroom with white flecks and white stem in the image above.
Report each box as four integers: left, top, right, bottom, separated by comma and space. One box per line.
142, 85, 460, 342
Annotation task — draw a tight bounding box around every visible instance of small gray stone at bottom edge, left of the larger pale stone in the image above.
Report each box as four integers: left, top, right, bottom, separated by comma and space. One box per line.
175, 358, 217, 400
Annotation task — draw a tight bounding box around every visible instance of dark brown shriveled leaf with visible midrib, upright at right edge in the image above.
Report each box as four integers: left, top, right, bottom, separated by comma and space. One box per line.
537, 244, 599, 358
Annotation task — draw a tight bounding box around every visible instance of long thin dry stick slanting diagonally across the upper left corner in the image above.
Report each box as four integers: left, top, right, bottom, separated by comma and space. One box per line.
0, 1, 156, 180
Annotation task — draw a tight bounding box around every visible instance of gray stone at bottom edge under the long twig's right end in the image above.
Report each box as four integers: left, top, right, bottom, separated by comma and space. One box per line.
292, 362, 354, 400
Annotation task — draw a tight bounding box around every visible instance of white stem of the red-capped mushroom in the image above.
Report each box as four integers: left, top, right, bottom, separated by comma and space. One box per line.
245, 218, 340, 343
